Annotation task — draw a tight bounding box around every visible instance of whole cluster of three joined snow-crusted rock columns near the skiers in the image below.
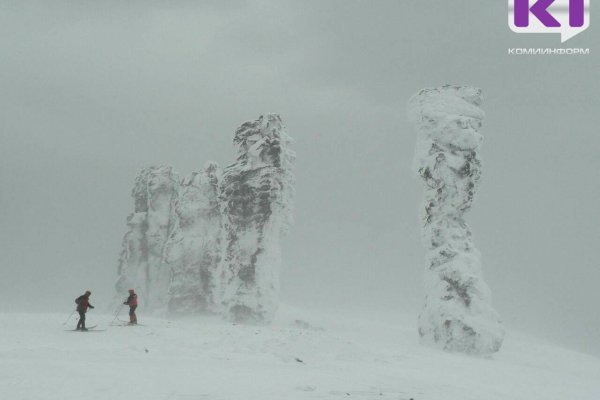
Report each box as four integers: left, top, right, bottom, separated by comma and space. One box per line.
116, 114, 295, 323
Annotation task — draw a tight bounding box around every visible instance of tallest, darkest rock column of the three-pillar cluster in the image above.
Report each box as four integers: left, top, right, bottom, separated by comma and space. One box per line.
220, 114, 294, 323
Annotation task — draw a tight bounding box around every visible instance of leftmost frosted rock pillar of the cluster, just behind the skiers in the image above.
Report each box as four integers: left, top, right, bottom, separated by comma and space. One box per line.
116, 166, 178, 310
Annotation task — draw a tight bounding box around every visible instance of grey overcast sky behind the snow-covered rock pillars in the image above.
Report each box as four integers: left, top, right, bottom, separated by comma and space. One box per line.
0, 0, 600, 354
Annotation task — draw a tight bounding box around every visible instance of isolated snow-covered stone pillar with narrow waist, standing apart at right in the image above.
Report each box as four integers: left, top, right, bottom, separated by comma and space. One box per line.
408, 86, 504, 354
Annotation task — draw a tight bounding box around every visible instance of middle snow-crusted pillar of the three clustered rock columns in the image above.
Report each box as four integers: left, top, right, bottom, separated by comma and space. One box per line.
165, 162, 222, 314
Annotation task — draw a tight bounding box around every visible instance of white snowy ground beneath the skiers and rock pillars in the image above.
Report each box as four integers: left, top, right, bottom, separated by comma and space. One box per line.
0, 307, 600, 400
